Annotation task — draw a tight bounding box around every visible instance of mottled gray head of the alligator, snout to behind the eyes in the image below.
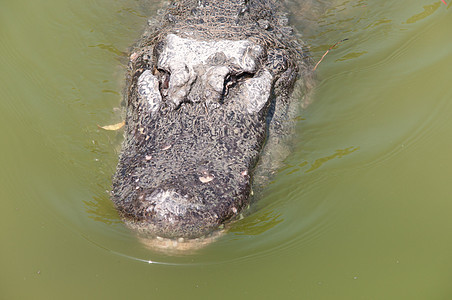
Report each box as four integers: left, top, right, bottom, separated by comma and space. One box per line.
113, 0, 306, 246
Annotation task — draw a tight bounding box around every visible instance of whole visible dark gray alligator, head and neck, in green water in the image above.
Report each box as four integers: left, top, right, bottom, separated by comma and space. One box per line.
112, 0, 313, 248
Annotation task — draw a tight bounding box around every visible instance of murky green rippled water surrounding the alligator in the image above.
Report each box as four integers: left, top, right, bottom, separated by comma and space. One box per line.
0, 0, 452, 299
